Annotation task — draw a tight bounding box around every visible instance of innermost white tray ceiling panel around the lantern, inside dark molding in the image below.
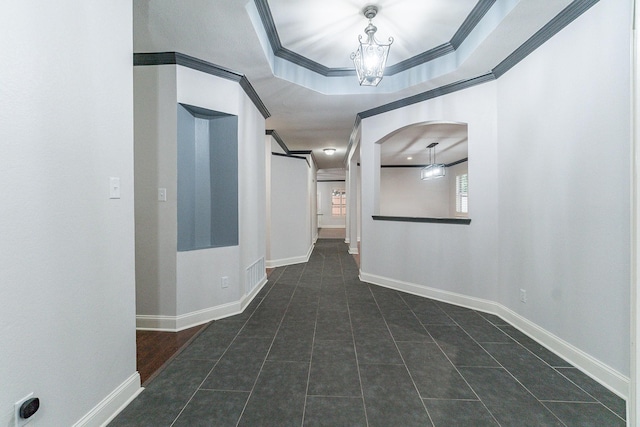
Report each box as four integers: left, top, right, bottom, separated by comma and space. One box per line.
268, 0, 477, 68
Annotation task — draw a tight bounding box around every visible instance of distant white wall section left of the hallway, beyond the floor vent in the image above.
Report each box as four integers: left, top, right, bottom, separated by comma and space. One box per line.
267, 156, 315, 267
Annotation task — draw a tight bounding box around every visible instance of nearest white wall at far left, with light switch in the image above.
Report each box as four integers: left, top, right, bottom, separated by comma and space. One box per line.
0, 0, 140, 427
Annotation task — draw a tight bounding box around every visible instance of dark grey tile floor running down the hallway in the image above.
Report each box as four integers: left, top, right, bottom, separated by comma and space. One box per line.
110, 239, 625, 427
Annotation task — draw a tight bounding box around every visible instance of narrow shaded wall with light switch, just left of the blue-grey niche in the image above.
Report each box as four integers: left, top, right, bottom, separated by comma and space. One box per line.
133, 65, 178, 316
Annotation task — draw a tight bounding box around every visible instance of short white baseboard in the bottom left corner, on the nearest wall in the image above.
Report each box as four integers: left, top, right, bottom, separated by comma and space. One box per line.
73, 372, 144, 427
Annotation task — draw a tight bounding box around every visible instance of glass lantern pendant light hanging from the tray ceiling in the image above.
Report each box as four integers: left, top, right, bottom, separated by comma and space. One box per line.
351, 6, 393, 86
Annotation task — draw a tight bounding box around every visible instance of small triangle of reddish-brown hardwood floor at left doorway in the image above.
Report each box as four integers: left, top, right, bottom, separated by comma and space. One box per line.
136, 324, 207, 386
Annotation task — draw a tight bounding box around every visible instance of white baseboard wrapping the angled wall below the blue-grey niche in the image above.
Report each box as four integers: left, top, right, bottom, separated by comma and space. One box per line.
136, 274, 267, 332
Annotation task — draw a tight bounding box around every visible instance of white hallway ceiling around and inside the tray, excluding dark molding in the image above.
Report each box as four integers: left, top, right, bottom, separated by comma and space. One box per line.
133, 0, 571, 169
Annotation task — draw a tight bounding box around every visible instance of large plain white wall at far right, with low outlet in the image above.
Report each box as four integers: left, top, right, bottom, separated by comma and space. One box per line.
496, 1, 631, 375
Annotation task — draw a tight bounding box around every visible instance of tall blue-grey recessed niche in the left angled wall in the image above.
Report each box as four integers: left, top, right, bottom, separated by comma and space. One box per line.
177, 104, 238, 251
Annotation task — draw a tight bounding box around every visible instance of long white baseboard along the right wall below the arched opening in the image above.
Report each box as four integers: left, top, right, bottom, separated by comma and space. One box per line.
360, 271, 630, 400
